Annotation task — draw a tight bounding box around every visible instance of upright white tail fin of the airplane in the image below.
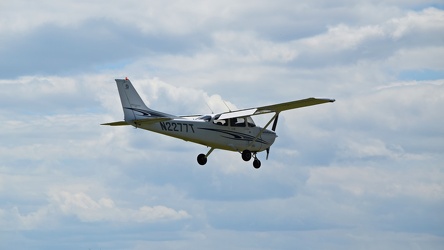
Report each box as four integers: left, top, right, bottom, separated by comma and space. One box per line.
116, 78, 176, 123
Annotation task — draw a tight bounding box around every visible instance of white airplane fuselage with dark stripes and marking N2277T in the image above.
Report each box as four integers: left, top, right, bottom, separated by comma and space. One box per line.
133, 114, 277, 152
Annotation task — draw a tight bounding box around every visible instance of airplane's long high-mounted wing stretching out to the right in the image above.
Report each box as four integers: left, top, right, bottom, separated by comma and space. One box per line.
219, 97, 335, 119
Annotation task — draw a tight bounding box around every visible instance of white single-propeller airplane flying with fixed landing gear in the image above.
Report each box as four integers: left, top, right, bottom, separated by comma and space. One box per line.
101, 77, 335, 169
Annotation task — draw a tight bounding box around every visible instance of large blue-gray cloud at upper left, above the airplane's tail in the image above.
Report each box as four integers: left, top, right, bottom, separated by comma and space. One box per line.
0, 19, 207, 78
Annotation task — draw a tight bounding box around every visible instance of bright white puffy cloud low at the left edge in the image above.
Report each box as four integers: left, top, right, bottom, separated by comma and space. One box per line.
0, 191, 192, 231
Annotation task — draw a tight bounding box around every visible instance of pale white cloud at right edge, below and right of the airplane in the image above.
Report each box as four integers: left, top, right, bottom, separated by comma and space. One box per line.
307, 165, 444, 201
